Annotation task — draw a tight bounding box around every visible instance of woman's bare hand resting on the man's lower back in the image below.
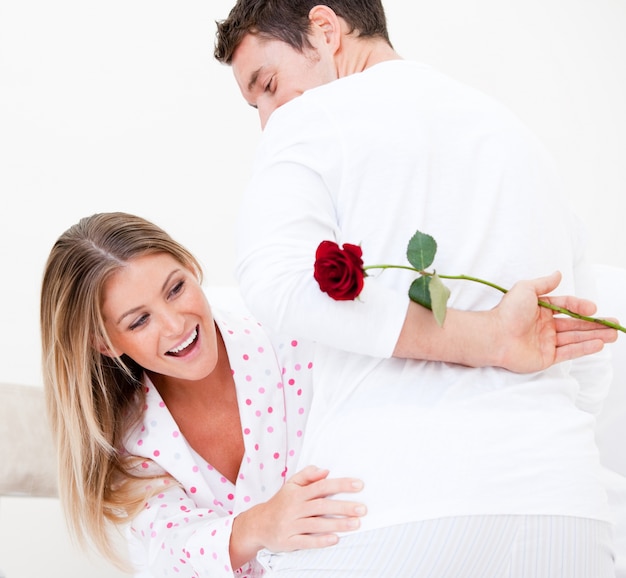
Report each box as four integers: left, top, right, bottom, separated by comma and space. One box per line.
230, 466, 366, 568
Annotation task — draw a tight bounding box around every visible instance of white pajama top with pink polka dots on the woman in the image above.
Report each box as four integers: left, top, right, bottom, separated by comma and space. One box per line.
126, 310, 313, 578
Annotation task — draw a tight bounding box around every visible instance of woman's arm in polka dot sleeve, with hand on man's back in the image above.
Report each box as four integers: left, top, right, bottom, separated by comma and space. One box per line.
129, 466, 365, 578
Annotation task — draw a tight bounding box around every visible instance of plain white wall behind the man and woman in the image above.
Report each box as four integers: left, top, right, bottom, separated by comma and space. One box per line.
0, 0, 626, 564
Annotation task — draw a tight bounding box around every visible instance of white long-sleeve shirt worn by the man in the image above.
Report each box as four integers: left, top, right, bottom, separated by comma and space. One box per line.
237, 61, 608, 529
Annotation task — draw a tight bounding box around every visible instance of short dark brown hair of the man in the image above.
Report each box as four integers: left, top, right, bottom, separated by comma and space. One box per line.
214, 0, 391, 64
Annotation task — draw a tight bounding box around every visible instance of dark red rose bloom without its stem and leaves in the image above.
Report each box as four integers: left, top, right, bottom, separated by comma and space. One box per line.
313, 241, 365, 301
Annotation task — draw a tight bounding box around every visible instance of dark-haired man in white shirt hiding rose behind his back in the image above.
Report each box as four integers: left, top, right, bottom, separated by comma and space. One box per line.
215, 0, 615, 578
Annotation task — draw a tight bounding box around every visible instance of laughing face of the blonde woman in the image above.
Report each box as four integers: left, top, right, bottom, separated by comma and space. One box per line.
102, 253, 218, 381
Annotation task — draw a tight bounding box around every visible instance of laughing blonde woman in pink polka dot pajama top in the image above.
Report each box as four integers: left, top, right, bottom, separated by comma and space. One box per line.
41, 213, 365, 577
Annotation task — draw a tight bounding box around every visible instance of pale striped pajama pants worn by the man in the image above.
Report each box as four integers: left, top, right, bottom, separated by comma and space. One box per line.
259, 516, 615, 578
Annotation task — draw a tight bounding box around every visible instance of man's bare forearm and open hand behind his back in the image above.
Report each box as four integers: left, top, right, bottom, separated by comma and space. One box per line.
393, 273, 617, 373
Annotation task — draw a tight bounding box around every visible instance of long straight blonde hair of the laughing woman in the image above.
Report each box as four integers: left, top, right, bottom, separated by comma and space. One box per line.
40, 212, 202, 567
